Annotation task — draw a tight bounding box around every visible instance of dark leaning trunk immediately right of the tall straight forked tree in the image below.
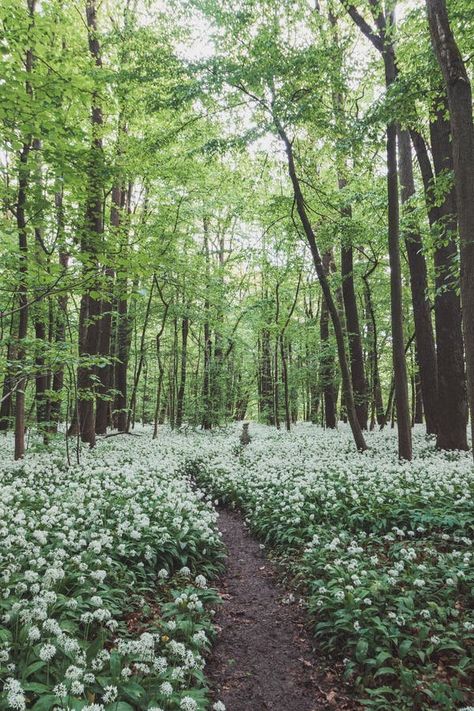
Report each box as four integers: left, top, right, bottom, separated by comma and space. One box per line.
398, 129, 438, 434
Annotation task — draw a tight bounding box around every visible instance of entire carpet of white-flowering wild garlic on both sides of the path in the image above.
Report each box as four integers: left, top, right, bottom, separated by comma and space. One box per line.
0, 424, 474, 711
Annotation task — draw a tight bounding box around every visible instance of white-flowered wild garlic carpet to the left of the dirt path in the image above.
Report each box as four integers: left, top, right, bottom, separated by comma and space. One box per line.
0, 436, 228, 711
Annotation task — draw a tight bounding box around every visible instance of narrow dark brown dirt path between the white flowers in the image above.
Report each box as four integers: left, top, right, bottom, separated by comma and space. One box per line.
206, 511, 357, 711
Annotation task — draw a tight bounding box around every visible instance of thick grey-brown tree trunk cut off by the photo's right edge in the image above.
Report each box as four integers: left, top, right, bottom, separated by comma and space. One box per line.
426, 0, 474, 452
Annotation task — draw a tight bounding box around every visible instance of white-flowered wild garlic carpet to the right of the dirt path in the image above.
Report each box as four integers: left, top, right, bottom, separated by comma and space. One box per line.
193, 425, 474, 710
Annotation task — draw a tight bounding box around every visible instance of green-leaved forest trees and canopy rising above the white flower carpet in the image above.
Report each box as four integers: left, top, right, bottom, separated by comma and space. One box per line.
0, 0, 474, 459
